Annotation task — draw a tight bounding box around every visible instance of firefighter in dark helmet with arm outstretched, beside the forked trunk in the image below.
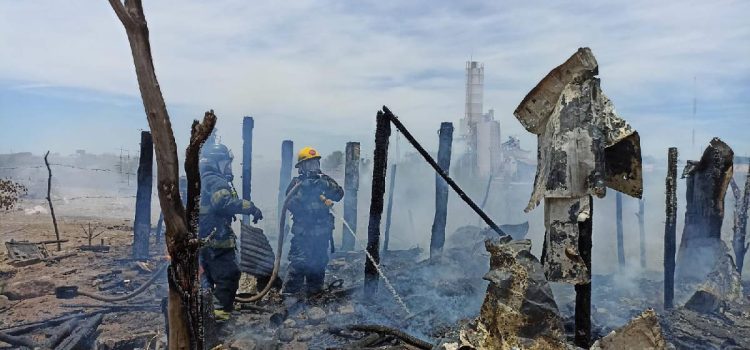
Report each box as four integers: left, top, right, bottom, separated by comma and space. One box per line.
198, 143, 263, 320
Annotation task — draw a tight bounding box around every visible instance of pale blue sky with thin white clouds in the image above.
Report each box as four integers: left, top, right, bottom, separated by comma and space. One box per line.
0, 0, 750, 159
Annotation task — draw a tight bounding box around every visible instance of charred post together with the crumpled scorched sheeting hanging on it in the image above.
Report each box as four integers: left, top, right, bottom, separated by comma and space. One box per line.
513, 48, 643, 348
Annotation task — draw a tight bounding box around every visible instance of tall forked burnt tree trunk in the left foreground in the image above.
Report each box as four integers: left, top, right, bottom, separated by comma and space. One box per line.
109, 0, 216, 349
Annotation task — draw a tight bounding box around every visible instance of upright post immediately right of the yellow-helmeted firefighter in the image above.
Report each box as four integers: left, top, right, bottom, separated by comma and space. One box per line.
341, 142, 362, 251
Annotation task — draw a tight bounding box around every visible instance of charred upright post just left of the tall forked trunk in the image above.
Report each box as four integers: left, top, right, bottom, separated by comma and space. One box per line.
133, 131, 154, 259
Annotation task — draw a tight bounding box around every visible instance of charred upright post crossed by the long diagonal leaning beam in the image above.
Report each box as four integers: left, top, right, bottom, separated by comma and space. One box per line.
430, 122, 453, 258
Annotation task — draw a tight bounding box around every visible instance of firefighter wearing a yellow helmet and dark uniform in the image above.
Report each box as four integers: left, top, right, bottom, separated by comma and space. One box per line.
283, 147, 344, 296
